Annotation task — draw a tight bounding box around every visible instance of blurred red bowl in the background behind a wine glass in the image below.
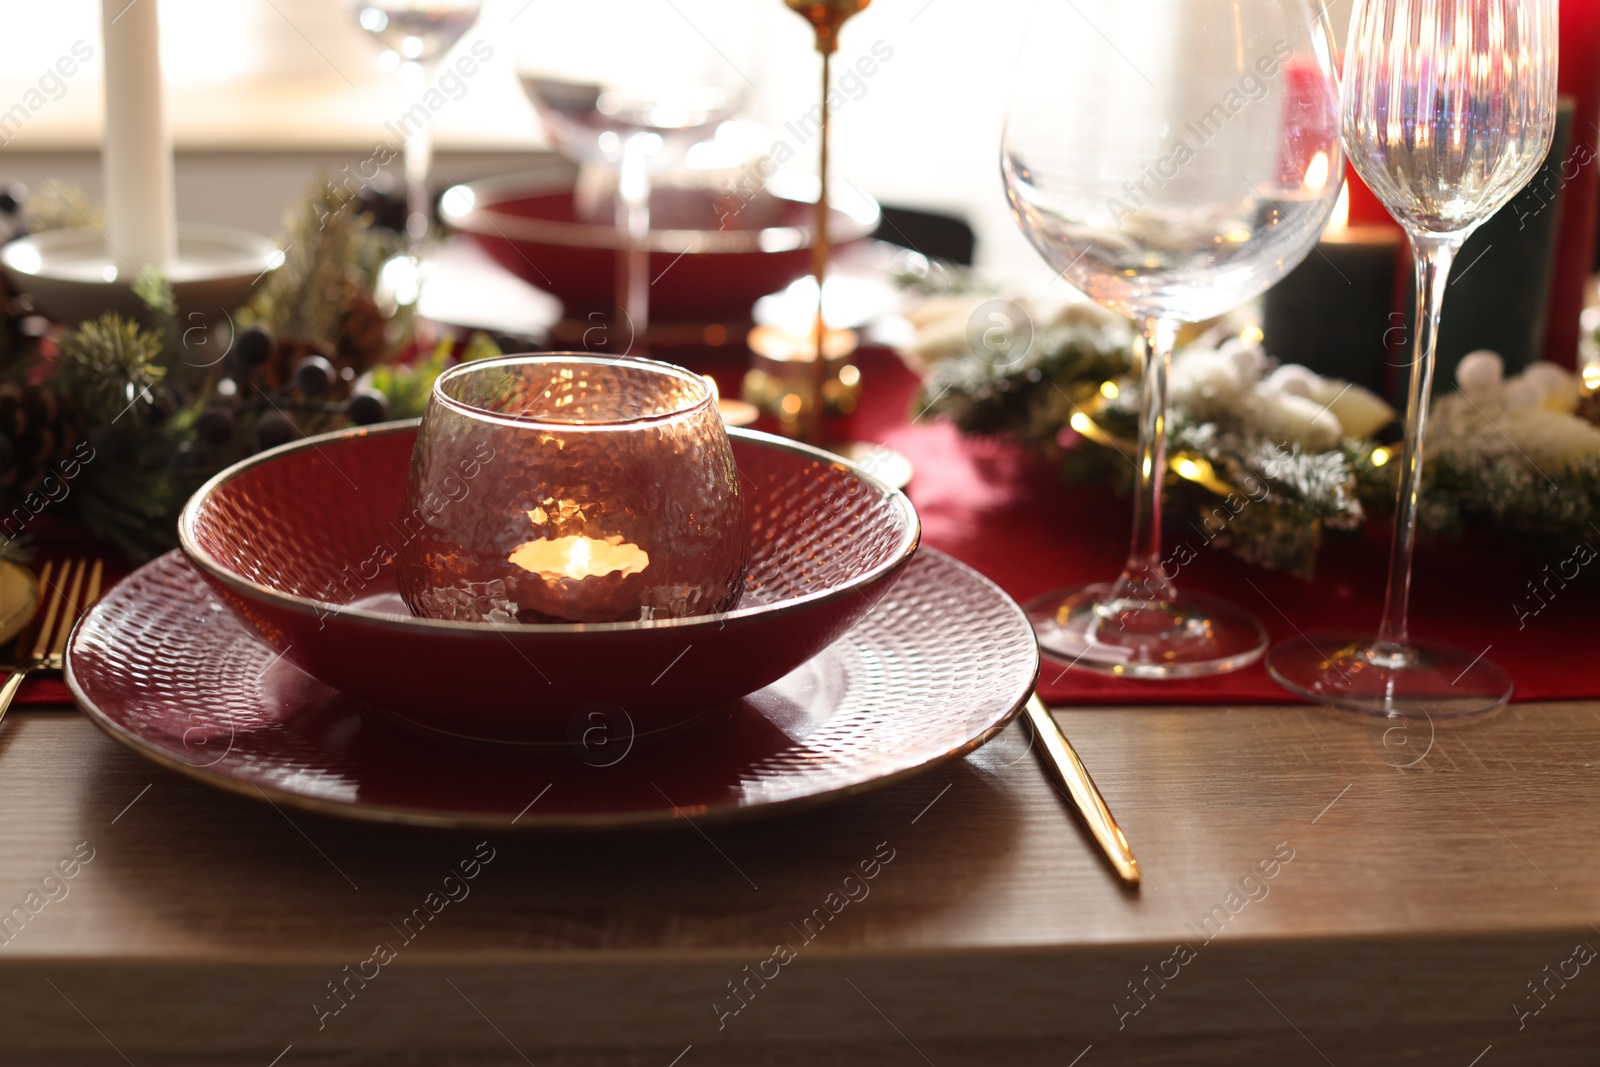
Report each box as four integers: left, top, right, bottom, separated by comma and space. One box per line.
440, 163, 878, 322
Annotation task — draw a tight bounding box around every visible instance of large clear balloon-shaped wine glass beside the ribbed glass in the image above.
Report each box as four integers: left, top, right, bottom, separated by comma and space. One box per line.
1002, 0, 1344, 678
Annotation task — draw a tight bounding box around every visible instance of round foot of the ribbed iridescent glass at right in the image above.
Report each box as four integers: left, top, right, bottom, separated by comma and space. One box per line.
1267, 633, 1512, 721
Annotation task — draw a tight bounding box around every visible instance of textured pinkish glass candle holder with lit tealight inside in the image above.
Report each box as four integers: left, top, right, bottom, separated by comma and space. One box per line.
400, 354, 749, 624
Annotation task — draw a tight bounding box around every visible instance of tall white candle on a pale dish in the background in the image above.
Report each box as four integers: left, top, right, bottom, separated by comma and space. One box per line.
101, 0, 178, 275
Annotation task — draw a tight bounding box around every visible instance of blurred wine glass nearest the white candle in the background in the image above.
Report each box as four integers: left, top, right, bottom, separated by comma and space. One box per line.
346, 0, 483, 242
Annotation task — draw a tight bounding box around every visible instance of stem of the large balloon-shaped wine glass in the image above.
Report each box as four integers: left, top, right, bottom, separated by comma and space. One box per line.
1112, 318, 1178, 605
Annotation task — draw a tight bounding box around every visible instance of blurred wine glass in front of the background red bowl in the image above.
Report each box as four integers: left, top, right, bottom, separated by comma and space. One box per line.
517, 0, 755, 348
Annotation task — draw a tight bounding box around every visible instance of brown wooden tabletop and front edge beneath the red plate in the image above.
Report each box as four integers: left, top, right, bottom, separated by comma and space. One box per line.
0, 702, 1600, 1067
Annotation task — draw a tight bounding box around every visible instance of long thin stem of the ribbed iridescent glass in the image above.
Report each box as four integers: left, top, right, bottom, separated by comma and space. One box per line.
1373, 234, 1461, 665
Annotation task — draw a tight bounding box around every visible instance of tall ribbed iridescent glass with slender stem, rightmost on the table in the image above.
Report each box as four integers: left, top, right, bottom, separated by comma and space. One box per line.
1267, 0, 1557, 720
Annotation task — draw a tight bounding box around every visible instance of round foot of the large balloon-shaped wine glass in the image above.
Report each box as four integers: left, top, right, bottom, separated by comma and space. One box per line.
1026, 582, 1267, 678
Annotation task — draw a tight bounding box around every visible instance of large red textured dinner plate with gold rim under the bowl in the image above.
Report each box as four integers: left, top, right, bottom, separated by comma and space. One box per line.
66, 549, 1038, 829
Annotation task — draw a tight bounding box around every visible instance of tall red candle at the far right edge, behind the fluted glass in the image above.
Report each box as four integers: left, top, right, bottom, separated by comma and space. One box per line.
1544, 0, 1600, 366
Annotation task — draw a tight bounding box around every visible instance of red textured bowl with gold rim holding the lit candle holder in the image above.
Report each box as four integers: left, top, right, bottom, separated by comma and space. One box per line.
178, 422, 920, 742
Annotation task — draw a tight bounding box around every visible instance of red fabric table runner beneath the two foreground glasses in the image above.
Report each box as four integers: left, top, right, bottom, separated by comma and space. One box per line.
854, 354, 1600, 704
